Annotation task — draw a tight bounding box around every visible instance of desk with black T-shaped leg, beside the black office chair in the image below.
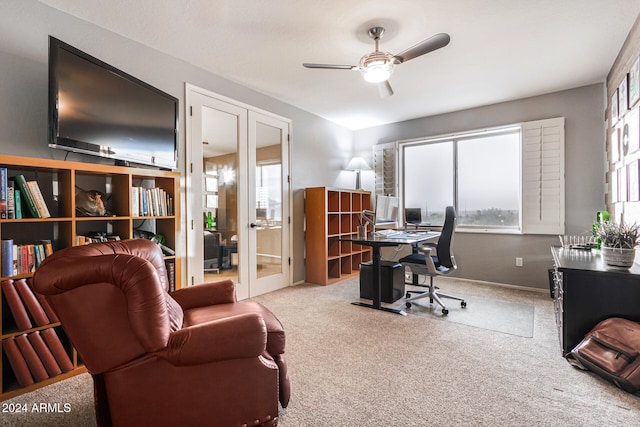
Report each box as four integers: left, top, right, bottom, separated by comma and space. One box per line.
340, 231, 440, 316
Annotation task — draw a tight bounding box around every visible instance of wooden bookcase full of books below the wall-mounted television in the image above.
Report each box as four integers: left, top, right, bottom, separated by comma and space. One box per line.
0, 155, 182, 401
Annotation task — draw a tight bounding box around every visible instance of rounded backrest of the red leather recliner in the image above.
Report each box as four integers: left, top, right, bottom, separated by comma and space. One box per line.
33, 239, 183, 374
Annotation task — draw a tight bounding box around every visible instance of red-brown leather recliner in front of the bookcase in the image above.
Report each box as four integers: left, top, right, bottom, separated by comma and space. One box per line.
33, 239, 290, 426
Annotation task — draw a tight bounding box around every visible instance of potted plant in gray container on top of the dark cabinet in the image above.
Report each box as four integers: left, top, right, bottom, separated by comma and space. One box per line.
594, 221, 640, 268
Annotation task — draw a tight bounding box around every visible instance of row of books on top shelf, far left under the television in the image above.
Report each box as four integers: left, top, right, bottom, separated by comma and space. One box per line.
0, 167, 51, 219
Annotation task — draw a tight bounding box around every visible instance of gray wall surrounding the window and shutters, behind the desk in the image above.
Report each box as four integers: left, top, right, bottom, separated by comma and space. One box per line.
354, 84, 605, 288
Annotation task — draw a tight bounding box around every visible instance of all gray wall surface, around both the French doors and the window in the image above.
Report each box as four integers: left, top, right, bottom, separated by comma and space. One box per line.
0, 0, 605, 288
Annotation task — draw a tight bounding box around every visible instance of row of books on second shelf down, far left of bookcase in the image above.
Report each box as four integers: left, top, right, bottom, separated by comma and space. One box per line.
0, 239, 53, 277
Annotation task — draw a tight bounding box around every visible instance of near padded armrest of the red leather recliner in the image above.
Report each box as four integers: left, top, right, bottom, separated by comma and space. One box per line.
158, 313, 267, 366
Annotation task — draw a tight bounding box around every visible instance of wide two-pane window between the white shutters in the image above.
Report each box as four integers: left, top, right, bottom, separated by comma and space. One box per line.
400, 127, 521, 230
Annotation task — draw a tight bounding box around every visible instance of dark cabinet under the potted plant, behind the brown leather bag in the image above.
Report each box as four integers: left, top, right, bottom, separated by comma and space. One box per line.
551, 246, 640, 356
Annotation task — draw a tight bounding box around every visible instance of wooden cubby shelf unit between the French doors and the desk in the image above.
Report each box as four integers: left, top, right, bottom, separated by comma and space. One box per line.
305, 187, 371, 285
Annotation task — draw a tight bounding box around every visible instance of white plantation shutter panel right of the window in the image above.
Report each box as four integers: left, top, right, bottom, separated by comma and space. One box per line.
522, 117, 564, 234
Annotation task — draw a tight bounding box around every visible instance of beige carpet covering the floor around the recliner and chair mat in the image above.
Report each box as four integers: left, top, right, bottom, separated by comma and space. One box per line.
0, 278, 640, 427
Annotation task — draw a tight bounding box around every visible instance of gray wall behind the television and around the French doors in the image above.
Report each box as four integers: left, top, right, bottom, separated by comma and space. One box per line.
0, 0, 352, 288
